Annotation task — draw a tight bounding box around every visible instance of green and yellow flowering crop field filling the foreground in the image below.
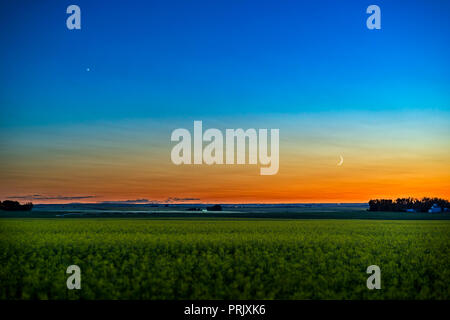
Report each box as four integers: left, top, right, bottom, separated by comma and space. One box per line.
0, 218, 450, 299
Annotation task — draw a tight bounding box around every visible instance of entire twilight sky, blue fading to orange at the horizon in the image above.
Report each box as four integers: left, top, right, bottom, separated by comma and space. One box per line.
0, 0, 450, 203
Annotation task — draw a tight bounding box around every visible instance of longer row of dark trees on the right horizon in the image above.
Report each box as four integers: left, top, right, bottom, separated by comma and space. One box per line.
369, 198, 450, 212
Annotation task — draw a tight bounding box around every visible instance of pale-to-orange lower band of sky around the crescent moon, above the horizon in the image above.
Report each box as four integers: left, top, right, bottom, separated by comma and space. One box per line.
0, 115, 450, 203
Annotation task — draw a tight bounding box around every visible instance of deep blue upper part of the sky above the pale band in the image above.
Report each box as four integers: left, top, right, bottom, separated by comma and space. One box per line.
0, 0, 450, 127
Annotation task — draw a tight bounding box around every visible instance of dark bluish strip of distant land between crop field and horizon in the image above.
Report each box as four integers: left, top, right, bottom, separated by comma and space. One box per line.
0, 206, 450, 220
